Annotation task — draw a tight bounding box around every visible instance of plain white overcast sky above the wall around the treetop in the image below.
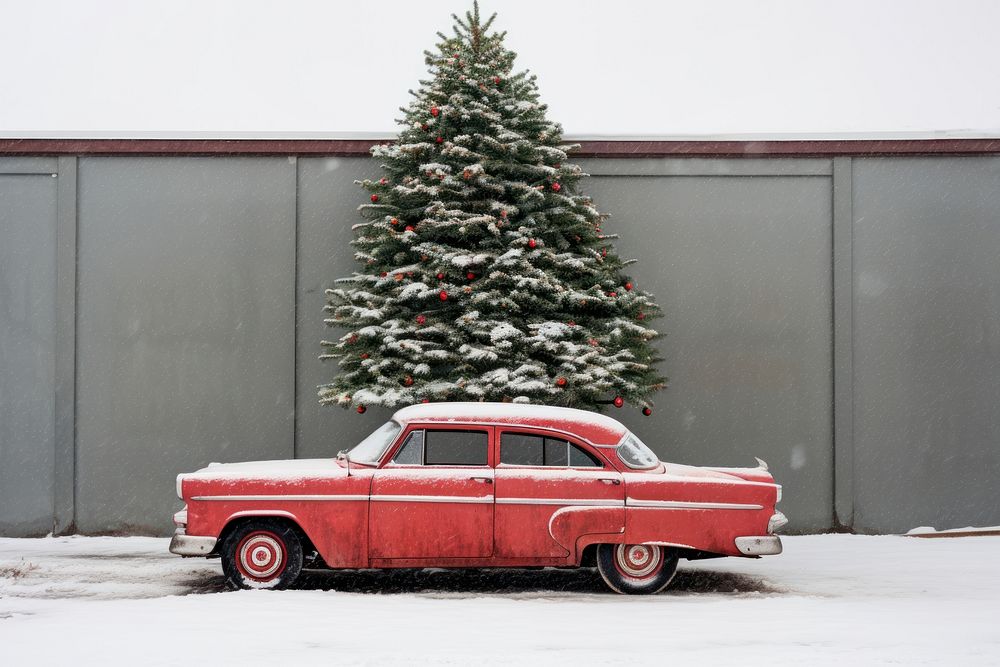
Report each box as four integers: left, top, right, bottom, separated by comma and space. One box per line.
0, 0, 1000, 137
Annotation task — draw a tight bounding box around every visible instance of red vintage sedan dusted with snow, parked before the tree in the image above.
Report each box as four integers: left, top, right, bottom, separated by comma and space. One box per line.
170, 403, 786, 593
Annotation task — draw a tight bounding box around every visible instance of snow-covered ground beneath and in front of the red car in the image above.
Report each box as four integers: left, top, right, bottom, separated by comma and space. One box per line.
0, 535, 1000, 667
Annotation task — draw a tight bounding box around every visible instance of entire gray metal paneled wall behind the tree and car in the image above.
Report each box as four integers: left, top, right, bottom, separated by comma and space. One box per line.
0, 157, 1000, 535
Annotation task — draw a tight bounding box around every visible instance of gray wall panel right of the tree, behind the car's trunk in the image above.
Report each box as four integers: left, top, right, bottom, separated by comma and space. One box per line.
587, 160, 833, 530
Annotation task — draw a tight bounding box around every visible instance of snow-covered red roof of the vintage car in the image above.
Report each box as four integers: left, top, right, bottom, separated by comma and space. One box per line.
392, 403, 628, 445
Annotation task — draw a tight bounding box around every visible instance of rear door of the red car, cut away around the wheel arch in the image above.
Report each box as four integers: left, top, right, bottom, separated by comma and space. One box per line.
494, 427, 625, 559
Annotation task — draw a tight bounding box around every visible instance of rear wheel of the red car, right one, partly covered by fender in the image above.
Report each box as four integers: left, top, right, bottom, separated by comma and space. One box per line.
597, 544, 677, 595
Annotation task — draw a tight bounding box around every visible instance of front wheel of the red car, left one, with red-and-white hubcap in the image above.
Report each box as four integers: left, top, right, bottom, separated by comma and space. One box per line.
221, 519, 302, 589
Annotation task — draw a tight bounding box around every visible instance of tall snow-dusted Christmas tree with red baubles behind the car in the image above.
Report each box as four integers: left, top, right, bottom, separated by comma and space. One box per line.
319, 3, 664, 414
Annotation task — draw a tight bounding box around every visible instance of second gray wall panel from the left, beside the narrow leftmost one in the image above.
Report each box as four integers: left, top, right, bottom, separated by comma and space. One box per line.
76, 157, 295, 533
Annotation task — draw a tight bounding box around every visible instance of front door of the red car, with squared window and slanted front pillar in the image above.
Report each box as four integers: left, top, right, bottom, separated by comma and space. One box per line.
369, 424, 494, 559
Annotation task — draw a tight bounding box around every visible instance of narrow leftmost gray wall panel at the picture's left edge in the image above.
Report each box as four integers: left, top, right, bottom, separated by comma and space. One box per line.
0, 159, 56, 535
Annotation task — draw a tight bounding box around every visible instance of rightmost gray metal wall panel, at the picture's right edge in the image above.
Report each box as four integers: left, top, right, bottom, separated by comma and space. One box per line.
854, 157, 1000, 532
